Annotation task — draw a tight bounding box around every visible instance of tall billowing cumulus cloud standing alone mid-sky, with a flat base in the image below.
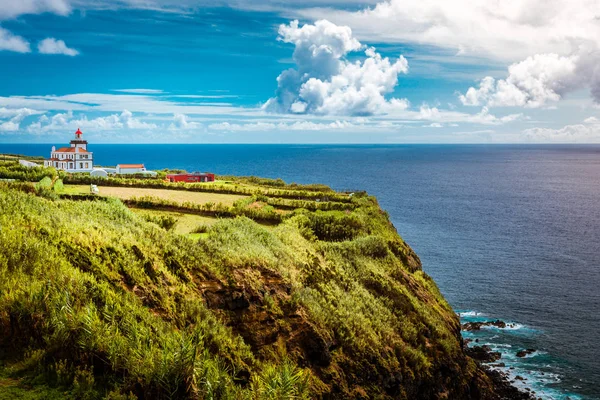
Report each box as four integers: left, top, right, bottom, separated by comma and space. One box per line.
264, 20, 409, 116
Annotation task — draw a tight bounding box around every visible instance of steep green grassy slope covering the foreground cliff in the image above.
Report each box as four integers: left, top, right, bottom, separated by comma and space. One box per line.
0, 184, 486, 399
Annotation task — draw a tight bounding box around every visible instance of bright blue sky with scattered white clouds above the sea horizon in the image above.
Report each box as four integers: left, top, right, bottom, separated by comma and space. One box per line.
0, 0, 600, 146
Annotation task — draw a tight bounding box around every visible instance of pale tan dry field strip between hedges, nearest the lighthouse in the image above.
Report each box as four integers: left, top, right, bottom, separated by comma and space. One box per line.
65, 185, 247, 206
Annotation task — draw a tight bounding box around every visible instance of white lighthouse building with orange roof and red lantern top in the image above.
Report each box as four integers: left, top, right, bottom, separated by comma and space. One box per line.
44, 129, 94, 172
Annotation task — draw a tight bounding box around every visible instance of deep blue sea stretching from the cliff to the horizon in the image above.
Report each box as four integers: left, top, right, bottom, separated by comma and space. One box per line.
0, 144, 600, 399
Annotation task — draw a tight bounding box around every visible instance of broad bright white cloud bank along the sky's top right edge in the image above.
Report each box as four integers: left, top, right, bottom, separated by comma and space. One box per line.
296, 0, 600, 62
